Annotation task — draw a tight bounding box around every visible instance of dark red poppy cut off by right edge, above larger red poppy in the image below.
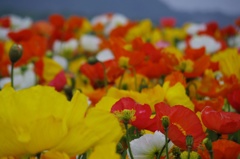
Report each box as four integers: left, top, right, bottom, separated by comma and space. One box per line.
227, 89, 240, 113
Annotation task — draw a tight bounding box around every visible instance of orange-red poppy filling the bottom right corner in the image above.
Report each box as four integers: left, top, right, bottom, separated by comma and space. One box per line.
198, 139, 240, 159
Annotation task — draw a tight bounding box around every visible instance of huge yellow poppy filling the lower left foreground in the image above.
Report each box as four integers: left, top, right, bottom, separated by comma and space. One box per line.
0, 86, 122, 157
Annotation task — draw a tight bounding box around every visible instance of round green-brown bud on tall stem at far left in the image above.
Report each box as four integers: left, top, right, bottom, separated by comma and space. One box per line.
9, 44, 23, 63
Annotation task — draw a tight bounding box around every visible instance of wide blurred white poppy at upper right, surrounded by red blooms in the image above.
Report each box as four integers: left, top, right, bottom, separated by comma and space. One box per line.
189, 35, 221, 54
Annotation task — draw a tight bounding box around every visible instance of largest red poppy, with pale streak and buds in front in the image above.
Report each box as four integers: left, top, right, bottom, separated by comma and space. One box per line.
155, 102, 206, 150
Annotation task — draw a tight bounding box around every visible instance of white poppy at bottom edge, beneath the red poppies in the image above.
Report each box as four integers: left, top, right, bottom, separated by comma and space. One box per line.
128, 131, 173, 159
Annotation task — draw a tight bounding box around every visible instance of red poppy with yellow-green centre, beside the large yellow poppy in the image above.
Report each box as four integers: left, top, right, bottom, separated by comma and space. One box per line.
111, 97, 157, 131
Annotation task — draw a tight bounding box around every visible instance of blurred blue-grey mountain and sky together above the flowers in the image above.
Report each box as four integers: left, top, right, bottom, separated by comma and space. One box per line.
0, 0, 240, 26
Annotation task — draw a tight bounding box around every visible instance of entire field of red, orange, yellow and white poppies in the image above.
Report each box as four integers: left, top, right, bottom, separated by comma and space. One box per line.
0, 13, 240, 159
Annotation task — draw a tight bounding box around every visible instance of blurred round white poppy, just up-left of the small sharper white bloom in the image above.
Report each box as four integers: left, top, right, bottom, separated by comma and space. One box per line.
80, 34, 102, 52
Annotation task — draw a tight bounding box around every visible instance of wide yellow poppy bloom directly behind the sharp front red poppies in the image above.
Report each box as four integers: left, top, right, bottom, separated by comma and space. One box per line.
96, 82, 194, 112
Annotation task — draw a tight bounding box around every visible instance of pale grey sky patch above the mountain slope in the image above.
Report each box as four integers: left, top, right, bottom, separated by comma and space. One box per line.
159, 0, 240, 16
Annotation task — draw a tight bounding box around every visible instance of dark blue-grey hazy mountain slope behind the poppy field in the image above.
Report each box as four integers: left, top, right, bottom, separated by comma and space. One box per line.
0, 0, 237, 26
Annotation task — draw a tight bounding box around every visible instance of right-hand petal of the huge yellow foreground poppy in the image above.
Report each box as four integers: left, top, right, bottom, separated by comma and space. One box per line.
54, 108, 122, 156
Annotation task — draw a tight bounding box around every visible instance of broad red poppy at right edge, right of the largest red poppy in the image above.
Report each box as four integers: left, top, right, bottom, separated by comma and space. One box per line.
201, 106, 240, 134
